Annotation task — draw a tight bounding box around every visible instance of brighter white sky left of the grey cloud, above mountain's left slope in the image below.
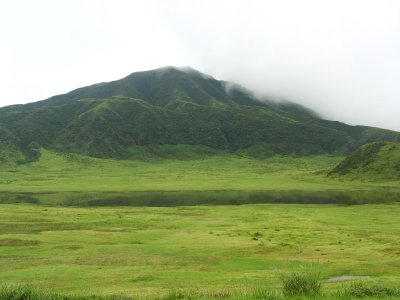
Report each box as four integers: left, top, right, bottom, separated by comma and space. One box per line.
0, 0, 184, 105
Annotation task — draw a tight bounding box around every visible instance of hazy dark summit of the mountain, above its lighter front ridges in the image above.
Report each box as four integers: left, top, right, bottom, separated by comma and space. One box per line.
43, 66, 265, 107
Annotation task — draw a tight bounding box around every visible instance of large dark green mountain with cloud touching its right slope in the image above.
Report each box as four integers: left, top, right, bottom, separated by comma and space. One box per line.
0, 67, 400, 160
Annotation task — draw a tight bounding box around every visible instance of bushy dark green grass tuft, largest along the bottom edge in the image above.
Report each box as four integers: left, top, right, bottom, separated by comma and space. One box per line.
281, 272, 322, 297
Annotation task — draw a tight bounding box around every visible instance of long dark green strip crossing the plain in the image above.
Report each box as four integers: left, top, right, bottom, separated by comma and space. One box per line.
81, 189, 400, 207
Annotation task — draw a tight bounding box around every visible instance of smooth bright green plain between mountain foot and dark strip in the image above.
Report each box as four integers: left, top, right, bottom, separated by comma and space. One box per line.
0, 149, 343, 192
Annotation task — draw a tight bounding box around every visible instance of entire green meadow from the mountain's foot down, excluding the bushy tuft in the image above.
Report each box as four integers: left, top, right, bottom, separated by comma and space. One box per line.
0, 149, 400, 300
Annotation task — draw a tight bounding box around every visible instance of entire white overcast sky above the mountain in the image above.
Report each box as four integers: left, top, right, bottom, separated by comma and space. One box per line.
0, 0, 400, 131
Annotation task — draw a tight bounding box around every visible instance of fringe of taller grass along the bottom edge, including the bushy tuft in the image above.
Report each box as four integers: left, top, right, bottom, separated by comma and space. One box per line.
0, 273, 400, 300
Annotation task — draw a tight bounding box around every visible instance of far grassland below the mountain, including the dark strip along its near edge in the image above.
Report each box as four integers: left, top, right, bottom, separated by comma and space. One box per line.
0, 149, 400, 206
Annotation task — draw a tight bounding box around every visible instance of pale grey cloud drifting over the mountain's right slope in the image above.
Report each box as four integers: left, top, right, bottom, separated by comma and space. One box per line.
164, 0, 400, 130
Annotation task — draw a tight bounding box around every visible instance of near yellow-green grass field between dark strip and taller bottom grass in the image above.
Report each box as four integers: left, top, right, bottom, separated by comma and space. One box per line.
0, 204, 400, 298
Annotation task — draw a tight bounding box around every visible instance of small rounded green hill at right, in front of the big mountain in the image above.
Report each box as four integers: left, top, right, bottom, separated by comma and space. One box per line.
329, 142, 400, 181
